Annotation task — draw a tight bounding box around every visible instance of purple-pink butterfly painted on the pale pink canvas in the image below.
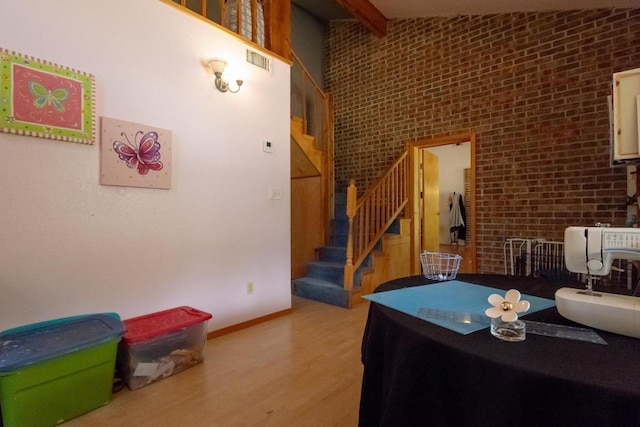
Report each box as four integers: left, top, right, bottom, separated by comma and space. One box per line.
113, 131, 163, 175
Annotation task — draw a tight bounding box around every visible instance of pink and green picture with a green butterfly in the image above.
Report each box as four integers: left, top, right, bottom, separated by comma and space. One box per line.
0, 48, 96, 144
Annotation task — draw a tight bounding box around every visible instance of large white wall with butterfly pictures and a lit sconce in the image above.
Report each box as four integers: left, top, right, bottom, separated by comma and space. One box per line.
0, 0, 291, 330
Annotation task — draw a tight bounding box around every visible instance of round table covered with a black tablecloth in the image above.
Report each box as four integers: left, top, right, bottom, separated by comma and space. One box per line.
359, 274, 640, 427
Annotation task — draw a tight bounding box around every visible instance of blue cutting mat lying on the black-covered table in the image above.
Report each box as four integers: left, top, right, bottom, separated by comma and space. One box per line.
363, 280, 556, 335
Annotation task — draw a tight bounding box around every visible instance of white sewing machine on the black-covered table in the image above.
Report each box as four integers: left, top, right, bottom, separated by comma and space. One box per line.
556, 227, 640, 338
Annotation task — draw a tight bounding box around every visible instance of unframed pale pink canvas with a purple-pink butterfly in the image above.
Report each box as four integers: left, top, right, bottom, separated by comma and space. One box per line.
100, 117, 171, 189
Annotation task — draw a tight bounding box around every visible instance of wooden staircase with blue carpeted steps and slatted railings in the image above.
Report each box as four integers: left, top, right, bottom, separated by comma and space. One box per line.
291, 53, 410, 308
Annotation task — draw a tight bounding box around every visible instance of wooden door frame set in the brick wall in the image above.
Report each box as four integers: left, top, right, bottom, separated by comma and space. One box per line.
407, 132, 478, 275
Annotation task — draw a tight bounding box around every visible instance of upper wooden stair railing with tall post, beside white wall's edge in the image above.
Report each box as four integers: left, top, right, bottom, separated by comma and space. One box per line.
291, 51, 335, 244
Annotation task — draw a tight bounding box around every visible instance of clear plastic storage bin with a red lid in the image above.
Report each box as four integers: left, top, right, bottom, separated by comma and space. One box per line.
117, 306, 212, 390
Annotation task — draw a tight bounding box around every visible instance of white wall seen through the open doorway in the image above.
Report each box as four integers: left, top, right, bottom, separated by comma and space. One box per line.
427, 142, 471, 245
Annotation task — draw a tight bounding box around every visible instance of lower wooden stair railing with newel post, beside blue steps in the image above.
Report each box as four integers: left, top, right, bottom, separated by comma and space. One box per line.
344, 151, 409, 290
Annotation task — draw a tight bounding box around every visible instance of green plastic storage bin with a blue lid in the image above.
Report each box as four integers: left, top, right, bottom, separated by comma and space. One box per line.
0, 313, 124, 427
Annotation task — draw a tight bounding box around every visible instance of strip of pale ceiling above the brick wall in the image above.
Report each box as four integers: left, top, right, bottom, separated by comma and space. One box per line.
369, 0, 640, 19
